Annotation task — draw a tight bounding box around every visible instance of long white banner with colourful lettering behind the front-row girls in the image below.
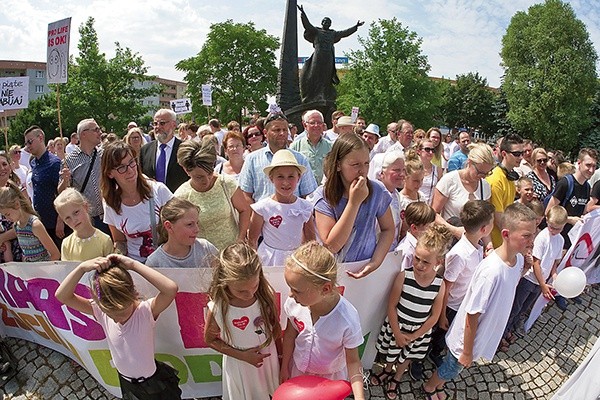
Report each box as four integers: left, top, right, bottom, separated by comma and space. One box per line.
0, 253, 400, 398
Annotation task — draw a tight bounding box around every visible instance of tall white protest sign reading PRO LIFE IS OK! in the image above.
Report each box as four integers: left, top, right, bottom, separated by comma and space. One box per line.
46, 17, 71, 83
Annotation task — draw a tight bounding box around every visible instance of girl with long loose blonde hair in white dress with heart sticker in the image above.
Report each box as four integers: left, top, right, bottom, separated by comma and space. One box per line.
204, 243, 281, 400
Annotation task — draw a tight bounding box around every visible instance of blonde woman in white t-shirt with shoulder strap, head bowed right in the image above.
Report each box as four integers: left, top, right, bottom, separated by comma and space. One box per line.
431, 143, 496, 238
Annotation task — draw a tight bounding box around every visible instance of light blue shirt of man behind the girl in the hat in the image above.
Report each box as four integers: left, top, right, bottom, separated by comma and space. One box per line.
239, 146, 317, 202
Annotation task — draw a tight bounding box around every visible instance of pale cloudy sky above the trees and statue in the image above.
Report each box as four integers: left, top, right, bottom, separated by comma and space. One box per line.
0, 0, 600, 87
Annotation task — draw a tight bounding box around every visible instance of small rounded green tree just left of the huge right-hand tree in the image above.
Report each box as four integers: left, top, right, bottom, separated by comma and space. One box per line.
442, 72, 494, 134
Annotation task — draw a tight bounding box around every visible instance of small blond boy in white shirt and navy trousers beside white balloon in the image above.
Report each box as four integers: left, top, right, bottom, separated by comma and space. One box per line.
506, 206, 569, 341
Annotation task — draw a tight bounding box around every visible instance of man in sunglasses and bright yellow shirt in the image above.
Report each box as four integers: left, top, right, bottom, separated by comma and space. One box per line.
485, 134, 523, 248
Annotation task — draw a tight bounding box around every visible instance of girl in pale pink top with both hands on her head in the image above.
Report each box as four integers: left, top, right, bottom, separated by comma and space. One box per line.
56, 254, 181, 400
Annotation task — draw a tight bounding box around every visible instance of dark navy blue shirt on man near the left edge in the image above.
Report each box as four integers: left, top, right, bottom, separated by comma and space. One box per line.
30, 150, 60, 230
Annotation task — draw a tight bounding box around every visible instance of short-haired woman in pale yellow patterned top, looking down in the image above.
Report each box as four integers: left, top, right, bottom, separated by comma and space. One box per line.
175, 140, 252, 250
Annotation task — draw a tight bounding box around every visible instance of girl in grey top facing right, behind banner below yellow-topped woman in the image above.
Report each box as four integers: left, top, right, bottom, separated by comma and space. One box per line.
146, 197, 219, 268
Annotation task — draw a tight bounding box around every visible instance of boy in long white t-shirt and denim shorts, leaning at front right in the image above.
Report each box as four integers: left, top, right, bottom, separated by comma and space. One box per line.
423, 203, 536, 400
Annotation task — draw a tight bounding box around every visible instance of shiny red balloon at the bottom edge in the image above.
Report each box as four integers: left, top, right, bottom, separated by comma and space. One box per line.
273, 375, 352, 400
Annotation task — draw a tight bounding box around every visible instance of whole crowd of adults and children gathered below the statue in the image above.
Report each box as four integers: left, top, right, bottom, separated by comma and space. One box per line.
0, 109, 600, 400
